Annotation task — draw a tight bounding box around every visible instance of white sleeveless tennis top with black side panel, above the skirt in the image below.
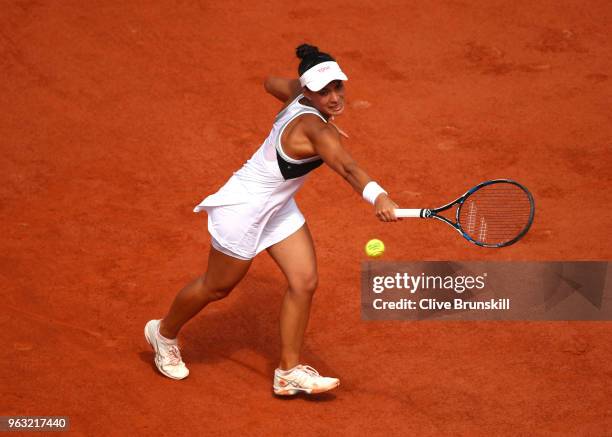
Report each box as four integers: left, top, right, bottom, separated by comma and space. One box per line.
194, 94, 327, 212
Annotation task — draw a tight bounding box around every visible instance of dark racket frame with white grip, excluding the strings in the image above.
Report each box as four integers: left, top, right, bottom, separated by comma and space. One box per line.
395, 179, 535, 248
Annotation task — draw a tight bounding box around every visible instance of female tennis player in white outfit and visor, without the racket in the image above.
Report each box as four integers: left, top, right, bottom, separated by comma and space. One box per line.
145, 44, 397, 395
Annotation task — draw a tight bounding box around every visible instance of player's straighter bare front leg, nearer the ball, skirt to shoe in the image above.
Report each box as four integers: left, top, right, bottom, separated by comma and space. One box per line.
268, 224, 318, 370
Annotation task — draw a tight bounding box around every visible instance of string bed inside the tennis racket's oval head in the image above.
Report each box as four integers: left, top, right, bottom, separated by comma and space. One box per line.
459, 184, 532, 245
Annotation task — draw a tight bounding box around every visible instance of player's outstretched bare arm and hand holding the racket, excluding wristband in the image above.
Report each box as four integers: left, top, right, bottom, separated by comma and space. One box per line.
305, 125, 398, 221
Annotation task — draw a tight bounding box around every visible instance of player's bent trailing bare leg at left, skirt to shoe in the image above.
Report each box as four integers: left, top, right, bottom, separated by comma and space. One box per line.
159, 247, 251, 339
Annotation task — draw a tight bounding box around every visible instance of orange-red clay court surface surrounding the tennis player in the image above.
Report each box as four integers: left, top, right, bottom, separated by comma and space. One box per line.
0, 0, 612, 436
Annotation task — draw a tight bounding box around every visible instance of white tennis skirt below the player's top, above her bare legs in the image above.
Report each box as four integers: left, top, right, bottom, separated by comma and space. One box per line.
195, 198, 306, 260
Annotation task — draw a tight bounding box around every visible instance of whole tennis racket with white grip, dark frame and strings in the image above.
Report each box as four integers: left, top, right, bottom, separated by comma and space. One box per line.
395, 179, 535, 247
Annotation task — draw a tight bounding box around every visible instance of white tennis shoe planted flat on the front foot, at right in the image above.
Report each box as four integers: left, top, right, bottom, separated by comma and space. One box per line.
273, 364, 340, 396
